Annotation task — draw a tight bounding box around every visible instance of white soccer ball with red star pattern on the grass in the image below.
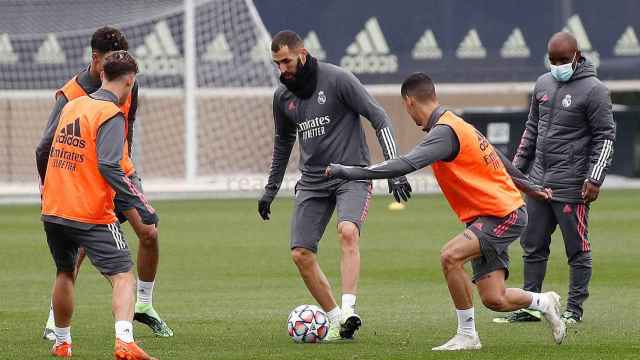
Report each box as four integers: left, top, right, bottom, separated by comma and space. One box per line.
287, 305, 329, 343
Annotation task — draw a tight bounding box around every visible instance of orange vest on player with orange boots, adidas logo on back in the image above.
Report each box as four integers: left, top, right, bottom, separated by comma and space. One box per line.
42, 96, 121, 224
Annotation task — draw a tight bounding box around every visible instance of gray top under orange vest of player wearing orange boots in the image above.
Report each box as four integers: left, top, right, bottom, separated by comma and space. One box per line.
36, 89, 157, 230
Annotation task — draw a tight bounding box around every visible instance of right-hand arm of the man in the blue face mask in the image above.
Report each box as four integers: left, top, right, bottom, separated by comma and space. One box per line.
582, 83, 616, 202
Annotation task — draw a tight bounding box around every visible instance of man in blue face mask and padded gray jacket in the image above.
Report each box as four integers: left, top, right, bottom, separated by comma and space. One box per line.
494, 32, 616, 325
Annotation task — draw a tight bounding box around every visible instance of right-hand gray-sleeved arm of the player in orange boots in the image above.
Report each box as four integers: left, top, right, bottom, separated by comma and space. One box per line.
96, 114, 158, 225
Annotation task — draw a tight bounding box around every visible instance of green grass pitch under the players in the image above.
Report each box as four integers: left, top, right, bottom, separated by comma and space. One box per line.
0, 190, 640, 360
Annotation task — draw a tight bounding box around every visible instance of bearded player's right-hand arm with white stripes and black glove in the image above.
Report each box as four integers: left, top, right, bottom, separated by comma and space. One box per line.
337, 71, 412, 202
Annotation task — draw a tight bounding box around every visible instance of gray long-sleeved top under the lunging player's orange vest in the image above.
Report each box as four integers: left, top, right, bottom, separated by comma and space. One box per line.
332, 107, 542, 193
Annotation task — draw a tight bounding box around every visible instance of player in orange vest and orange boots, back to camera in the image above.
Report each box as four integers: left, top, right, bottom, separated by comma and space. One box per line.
38, 51, 158, 360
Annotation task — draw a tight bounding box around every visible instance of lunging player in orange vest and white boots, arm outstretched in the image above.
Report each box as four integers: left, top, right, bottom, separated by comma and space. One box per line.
326, 73, 566, 351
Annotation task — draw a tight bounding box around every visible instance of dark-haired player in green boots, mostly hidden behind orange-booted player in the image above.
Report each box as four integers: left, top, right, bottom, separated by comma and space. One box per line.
37, 26, 173, 340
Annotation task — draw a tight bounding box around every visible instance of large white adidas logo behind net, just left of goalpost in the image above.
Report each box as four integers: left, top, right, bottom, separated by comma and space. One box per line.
135, 21, 184, 75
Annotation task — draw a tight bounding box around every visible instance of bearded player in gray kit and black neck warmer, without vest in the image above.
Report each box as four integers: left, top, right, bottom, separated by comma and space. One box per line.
258, 30, 411, 341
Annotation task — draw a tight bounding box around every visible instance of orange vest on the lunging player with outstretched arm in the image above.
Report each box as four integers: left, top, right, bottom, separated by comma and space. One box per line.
431, 111, 524, 223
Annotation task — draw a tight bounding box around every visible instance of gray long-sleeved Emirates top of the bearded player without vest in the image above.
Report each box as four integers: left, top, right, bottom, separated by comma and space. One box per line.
265, 62, 397, 198
